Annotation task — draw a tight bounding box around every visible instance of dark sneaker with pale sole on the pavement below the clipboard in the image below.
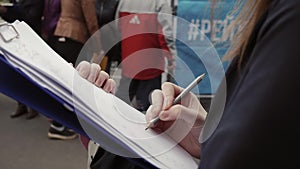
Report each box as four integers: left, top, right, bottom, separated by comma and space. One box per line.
48, 124, 77, 140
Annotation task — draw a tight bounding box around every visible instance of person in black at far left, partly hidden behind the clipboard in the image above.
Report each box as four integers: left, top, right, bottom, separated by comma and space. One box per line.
0, 0, 44, 119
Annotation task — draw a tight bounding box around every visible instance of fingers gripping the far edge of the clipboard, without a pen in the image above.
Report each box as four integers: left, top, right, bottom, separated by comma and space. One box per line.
76, 61, 116, 94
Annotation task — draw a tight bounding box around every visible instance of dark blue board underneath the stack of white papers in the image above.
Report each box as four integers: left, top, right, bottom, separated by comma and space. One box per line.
0, 54, 155, 168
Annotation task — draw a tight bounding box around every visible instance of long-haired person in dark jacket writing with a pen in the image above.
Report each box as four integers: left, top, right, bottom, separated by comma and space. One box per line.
146, 0, 300, 169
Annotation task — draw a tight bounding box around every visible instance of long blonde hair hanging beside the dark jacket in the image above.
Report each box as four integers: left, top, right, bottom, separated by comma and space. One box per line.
211, 0, 271, 62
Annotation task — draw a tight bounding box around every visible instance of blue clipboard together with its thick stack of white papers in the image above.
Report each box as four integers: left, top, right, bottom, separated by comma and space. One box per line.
0, 22, 198, 168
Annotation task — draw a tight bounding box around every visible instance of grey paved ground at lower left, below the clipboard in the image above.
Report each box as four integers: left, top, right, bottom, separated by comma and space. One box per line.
0, 93, 87, 169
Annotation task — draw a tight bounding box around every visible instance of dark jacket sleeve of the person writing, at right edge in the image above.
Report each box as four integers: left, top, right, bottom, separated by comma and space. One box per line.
199, 0, 300, 169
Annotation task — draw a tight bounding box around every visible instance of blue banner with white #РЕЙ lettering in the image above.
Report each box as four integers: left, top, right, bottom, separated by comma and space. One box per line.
175, 0, 234, 95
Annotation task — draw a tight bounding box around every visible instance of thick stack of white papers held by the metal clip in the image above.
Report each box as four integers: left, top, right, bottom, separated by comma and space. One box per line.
0, 21, 198, 169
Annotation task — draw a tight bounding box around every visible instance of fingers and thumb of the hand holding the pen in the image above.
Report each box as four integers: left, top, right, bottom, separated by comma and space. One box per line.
146, 83, 206, 130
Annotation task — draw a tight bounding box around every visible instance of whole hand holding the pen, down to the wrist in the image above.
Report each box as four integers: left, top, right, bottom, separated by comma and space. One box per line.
146, 82, 207, 158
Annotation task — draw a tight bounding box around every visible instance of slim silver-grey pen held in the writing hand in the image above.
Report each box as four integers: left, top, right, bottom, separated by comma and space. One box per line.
145, 73, 205, 130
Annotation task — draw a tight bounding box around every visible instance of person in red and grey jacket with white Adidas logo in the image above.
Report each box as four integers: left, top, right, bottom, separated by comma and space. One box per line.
116, 0, 176, 111
